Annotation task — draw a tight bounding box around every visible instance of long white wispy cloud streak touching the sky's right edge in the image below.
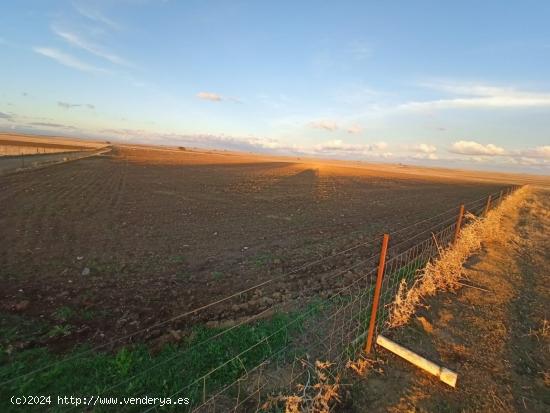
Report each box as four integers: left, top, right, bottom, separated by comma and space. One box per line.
399, 82, 550, 110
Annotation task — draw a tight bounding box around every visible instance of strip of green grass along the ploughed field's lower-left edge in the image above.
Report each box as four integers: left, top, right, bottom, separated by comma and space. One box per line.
0, 312, 311, 411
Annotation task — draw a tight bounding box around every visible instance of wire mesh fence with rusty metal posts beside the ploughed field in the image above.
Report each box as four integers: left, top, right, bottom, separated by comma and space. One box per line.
0, 186, 518, 412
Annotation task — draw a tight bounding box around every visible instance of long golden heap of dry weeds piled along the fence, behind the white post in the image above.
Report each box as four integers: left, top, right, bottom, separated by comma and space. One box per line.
388, 187, 529, 327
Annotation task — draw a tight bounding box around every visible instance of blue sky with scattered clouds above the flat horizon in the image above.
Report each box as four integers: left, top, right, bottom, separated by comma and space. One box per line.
0, 0, 550, 174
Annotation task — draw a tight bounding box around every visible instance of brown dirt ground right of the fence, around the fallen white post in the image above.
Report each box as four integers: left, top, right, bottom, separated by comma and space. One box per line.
342, 190, 550, 412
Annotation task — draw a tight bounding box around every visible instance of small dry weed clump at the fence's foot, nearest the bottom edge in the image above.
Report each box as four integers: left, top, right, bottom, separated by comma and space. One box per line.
261, 360, 340, 413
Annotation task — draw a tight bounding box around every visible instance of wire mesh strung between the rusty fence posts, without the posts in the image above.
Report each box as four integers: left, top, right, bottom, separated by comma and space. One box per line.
2, 186, 518, 412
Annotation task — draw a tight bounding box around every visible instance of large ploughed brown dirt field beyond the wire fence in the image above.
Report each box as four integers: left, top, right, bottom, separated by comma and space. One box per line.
0, 145, 544, 354
